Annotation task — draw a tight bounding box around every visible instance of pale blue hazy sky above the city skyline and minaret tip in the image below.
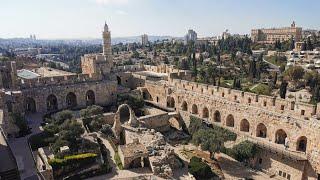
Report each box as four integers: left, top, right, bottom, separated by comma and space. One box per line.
0, 0, 320, 39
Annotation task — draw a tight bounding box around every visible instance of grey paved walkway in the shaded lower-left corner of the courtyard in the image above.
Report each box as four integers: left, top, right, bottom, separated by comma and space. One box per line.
8, 114, 42, 180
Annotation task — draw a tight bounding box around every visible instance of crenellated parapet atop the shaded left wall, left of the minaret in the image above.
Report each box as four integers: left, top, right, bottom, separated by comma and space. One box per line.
19, 74, 100, 88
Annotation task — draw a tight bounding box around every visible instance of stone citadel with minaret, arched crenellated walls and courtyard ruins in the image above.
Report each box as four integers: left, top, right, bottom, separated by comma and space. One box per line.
0, 24, 320, 180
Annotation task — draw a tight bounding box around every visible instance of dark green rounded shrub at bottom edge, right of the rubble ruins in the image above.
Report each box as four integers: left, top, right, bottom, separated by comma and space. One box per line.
188, 157, 217, 179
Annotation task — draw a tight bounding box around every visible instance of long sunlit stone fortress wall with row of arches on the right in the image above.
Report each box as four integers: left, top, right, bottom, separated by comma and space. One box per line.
124, 66, 320, 179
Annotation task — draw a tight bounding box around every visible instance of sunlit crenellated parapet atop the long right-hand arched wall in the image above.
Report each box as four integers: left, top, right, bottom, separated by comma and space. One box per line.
169, 79, 317, 120
